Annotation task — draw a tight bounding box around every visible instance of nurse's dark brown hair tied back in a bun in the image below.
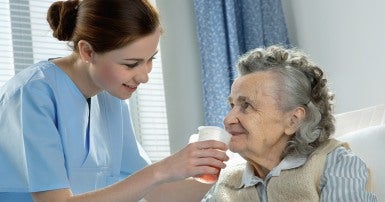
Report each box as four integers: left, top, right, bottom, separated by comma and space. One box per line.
47, 0, 160, 53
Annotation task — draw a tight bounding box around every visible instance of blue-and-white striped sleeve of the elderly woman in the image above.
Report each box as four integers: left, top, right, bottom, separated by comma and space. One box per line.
321, 147, 377, 202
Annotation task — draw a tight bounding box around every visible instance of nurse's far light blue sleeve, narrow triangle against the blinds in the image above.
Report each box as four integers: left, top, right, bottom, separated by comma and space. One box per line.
121, 101, 151, 178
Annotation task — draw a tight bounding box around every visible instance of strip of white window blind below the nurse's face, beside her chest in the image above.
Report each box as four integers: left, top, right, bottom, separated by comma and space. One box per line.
129, 51, 170, 162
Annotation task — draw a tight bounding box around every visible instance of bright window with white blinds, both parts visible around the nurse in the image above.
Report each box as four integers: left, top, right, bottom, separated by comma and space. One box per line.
0, 0, 170, 161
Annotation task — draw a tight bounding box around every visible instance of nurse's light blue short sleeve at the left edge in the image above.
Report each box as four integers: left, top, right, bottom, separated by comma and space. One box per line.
0, 84, 69, 192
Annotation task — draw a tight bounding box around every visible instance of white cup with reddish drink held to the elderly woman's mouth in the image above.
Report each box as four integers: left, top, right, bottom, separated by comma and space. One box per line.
190, 126, 231, 184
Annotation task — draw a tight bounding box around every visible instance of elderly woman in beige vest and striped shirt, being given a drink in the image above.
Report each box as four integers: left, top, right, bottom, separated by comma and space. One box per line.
207, 46, 376, 202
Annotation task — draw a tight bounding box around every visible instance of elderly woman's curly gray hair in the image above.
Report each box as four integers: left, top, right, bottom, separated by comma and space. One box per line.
237, 46, 335, 155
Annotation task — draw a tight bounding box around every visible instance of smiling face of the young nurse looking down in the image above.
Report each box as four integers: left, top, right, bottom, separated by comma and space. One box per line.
90, 30, 161, 100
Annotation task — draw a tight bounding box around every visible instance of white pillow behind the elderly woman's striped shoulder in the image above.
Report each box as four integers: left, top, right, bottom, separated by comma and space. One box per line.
337, 125, 385, 201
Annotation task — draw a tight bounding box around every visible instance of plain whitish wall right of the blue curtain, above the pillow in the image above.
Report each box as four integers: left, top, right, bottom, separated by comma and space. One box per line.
282, 0, 385, 113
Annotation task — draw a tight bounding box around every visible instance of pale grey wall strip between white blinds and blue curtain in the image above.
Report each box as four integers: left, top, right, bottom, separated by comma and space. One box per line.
156, 0, 204, 153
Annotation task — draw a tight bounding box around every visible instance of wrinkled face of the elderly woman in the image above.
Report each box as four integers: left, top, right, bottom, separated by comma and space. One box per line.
224, 72, 289, 159
